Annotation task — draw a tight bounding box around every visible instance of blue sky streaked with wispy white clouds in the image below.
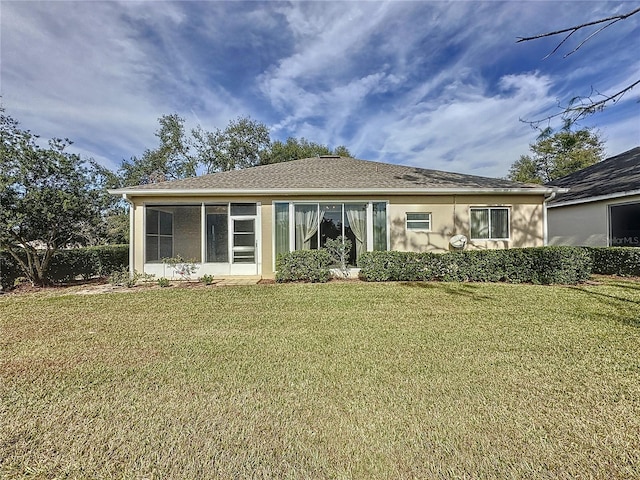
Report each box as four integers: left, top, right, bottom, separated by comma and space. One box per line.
0, 0, 640, 177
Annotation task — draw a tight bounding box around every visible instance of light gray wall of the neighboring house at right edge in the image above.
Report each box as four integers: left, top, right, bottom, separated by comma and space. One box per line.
547, 195, 640, 247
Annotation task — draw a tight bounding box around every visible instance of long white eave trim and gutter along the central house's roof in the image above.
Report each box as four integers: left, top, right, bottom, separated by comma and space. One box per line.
108, 187, 569, 197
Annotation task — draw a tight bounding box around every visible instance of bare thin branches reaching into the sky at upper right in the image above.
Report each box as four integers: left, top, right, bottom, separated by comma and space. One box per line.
516, 8, 640, 127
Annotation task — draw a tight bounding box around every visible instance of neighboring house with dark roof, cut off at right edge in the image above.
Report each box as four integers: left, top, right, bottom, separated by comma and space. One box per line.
547, 147, 640, 247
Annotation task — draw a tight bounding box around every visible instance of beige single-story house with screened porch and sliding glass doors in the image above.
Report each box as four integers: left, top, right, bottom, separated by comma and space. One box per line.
111, 156, 558, 278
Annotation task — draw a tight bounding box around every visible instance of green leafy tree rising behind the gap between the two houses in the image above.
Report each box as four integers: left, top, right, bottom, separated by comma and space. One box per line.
507, 126, 604, 184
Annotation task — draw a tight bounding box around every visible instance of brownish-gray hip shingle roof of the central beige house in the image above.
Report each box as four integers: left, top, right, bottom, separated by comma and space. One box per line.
112, 156, 551, 195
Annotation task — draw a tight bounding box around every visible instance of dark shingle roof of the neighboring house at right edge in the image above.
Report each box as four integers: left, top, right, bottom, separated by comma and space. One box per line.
547, 147, 640, 205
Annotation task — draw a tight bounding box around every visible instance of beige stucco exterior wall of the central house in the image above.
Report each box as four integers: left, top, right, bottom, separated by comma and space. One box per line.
132, 195, 544, 278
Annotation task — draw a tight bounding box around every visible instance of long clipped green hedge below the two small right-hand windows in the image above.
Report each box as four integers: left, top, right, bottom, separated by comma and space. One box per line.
358, 247, 592, 284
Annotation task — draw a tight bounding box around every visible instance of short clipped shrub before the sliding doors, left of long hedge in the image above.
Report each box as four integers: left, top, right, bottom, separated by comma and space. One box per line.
276, 249, 331, 283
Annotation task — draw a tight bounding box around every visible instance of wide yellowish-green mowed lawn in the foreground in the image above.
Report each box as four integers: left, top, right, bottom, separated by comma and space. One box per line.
0, 279, 640, 479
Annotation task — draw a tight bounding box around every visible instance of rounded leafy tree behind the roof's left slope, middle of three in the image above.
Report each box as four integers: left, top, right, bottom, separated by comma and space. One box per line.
192, 117, 271, 173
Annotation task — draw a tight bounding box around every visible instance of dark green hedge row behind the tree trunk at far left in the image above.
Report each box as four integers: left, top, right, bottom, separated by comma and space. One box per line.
0, 245, 129, 289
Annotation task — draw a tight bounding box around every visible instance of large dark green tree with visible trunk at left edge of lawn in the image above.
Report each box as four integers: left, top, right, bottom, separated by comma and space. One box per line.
0, 107, 100, 284
